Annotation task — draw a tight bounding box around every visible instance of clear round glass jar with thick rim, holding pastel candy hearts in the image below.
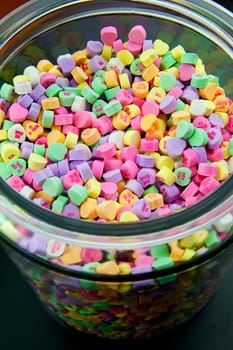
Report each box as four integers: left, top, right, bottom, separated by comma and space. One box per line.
0, 0, 233, 339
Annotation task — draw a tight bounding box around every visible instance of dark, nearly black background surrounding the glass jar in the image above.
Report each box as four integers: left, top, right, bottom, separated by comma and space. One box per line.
0, 0, 233, 350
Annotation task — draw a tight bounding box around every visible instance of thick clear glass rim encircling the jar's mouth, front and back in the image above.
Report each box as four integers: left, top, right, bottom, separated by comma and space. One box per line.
0, 0, 233, 245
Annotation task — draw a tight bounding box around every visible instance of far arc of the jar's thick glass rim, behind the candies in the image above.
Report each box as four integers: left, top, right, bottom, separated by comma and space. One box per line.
0, 0, 233, 68
